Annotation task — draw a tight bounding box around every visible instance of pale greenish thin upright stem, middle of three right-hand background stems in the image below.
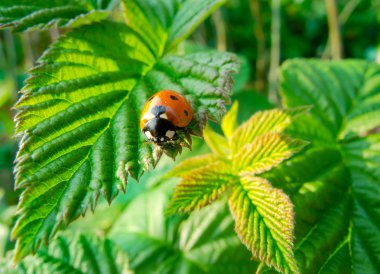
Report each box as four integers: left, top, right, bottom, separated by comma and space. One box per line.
268, 0, 281, 104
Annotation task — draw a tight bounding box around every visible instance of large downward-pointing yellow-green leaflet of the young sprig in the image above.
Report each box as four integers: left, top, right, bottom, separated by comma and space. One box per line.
228, 176, 298, 273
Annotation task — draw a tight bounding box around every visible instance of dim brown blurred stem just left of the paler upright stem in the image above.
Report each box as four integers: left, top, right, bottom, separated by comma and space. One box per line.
249, 0, 268, 92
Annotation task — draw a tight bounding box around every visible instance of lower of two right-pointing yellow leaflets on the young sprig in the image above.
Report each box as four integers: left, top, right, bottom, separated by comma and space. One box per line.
232, 133, 307, 175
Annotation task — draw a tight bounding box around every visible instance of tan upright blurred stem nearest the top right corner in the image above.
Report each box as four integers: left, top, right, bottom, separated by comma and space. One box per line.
326, 0, 342, 59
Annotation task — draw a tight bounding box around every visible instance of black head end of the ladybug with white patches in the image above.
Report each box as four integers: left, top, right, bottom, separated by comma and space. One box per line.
143, 117, 178, 145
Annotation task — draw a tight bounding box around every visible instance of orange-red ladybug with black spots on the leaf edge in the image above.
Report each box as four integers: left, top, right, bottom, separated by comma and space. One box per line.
140, 90, 193, 145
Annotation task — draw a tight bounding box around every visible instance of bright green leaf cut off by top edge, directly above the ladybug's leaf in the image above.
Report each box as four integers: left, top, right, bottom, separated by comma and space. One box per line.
123, 0, 226, 52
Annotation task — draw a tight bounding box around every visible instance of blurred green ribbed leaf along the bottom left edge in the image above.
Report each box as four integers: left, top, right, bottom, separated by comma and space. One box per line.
0, 233, 133, 274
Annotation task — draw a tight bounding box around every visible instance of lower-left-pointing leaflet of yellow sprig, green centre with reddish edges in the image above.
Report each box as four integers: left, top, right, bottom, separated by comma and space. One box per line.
166, 162, 238, 214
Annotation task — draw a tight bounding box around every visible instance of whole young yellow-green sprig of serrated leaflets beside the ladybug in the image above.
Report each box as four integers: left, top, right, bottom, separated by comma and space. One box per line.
167, 104, 306, 273
